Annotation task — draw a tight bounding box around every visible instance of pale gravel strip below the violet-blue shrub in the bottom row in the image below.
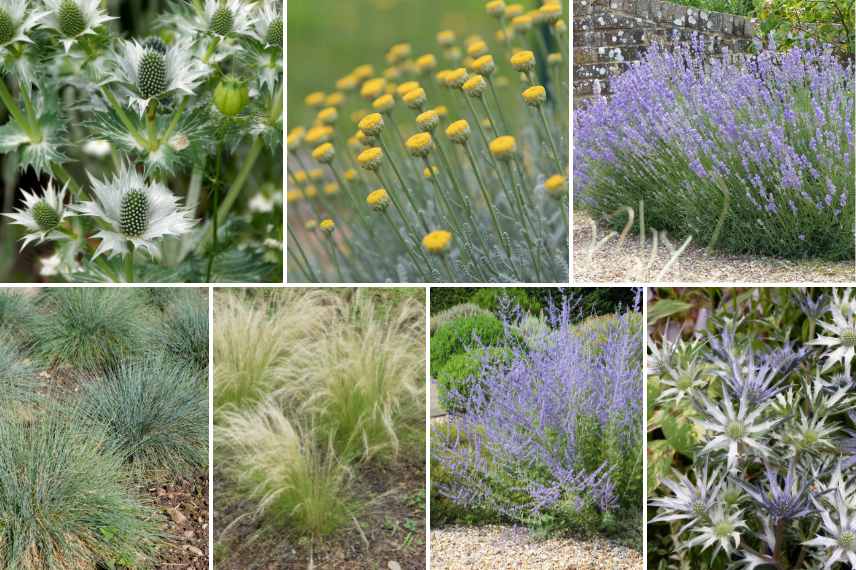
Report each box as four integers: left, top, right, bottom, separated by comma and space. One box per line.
431, 526, 642, 570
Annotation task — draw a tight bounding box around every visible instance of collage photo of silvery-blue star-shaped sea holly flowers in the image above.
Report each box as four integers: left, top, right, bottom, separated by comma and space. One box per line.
647, 287, 856, 570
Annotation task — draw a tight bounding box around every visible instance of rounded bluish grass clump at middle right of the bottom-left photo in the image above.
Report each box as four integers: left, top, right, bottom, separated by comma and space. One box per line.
80, 357, 208, 474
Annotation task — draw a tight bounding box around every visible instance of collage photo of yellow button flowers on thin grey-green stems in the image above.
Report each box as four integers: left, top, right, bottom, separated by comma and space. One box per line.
287, 0, 570, 283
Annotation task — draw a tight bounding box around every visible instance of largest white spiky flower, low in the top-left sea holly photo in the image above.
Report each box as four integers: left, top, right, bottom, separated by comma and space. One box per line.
75, 162, 196, 257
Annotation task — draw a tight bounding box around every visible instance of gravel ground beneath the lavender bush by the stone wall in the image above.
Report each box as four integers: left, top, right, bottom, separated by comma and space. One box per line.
574, 212, 856, 283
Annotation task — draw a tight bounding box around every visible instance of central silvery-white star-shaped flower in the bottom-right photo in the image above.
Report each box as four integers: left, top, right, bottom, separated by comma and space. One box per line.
696, 390, 783, 472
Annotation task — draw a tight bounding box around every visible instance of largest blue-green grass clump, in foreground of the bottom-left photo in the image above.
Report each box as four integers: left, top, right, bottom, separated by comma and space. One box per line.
0, 410, 159, 570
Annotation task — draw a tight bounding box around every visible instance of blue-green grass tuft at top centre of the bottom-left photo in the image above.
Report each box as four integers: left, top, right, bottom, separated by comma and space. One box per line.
34, 287, 151, 371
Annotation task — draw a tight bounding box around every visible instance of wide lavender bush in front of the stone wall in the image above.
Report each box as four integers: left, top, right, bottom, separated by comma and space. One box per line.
574, 38, 856, 260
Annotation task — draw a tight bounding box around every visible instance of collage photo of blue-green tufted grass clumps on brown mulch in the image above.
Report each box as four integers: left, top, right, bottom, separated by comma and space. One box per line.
0, 287, 209, 570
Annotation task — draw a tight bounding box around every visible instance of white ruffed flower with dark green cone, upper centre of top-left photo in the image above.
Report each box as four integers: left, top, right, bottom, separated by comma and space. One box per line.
113, 40, 205, 116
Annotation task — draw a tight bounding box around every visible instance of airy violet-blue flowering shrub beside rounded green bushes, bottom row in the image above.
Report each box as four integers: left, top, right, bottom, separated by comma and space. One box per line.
433, 301, 642, 530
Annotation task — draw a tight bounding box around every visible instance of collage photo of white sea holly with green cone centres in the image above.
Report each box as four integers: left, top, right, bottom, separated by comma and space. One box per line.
0, 0, 284, 283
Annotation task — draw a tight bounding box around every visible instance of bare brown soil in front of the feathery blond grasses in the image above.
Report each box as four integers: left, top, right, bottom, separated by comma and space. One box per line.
214, 458, 426, 570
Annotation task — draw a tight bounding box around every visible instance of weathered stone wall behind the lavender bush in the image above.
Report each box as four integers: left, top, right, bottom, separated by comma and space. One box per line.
573, 0, 755, 98
